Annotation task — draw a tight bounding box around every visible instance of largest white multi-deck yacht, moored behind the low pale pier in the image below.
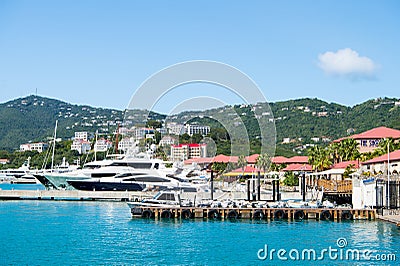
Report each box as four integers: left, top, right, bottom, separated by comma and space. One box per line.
44, 153, 200, 190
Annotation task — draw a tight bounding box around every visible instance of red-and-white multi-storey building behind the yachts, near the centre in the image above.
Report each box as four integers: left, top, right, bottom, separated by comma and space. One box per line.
171, 143, 207, 161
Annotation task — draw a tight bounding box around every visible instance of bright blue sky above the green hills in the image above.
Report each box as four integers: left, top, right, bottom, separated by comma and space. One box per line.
0, 0, 400, 113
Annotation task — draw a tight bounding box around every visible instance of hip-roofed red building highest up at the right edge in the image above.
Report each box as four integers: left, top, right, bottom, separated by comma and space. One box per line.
334, 127, 400, 153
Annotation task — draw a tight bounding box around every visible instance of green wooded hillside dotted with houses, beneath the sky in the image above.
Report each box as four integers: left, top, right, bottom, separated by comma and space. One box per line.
0, 95, 400, 155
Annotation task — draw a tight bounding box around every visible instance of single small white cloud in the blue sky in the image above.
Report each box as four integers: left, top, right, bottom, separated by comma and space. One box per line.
318, 48, 378, 79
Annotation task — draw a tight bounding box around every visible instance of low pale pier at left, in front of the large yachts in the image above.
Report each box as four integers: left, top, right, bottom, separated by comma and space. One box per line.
0, 190, 154, 201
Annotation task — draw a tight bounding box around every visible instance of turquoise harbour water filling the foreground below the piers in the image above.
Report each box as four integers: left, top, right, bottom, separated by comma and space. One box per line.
0, 201, 400, 265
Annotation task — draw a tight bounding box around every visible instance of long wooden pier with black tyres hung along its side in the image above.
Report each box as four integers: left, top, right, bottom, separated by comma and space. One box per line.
131, 207, 376, 221
